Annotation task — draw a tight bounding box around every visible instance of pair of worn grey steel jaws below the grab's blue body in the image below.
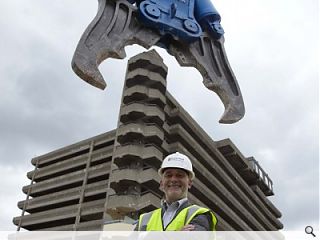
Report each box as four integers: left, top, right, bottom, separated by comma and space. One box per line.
72, 0, 245, 124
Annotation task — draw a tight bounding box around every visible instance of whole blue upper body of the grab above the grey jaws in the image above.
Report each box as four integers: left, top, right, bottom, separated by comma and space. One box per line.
127, 0, 224, 42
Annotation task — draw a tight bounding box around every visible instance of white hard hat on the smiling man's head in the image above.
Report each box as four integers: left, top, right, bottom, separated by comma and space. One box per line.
158, 152, 194, 179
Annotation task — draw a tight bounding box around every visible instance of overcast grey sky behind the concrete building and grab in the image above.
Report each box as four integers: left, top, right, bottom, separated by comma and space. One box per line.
0, 0, 319, 231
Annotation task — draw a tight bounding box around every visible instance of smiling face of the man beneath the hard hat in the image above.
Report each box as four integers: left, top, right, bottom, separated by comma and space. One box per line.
160, 168, 192, 203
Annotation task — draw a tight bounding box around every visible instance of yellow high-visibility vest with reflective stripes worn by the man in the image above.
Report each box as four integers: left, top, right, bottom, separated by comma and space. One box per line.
138, 205, 217, 231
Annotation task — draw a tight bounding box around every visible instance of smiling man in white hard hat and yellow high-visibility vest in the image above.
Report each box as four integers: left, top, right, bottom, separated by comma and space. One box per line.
135, 152, 217, 231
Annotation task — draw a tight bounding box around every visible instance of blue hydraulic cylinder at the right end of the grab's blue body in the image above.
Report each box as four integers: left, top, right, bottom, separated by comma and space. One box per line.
194, 0, 224, 39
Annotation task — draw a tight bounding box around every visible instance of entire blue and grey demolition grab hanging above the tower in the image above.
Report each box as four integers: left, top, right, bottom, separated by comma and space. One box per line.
72, 0, 245, 123
